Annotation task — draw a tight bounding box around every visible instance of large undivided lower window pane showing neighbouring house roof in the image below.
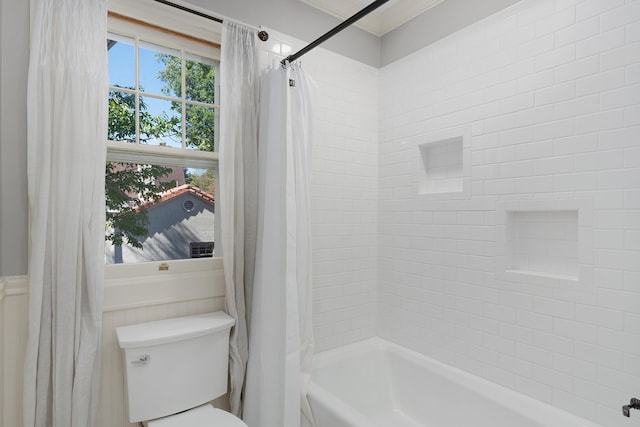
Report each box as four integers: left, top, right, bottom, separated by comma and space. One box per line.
105, 162, 215, 264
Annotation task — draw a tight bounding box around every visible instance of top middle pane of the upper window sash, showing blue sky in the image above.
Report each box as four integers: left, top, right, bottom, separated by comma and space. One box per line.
138, 42, 182, 98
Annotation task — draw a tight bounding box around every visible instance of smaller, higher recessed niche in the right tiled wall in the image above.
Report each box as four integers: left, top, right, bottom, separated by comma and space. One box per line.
417, 128, 470, 194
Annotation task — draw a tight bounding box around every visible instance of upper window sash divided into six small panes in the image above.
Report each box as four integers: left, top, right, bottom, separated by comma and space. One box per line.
107, 33, 217, 151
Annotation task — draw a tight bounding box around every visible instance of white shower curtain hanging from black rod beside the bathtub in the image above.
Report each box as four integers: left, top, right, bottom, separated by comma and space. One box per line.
244, 63, 313, 427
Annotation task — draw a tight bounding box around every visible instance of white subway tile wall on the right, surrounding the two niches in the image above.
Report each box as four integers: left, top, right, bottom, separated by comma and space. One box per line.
378, 0, 640, 427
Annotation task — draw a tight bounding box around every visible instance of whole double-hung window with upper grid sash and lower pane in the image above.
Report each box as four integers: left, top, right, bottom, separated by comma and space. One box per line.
105, 8, 219, 264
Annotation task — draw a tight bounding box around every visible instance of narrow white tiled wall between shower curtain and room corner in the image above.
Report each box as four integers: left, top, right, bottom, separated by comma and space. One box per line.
303, 49, 379, 351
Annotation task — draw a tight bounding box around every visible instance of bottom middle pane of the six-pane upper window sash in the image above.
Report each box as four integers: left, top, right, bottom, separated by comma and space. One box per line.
140, 96, 182, 148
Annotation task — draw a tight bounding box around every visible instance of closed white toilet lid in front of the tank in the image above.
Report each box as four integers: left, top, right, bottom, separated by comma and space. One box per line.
145, 403, 247, 427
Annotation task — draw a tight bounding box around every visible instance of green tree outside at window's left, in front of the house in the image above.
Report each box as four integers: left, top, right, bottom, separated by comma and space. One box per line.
105, 91, 176, 248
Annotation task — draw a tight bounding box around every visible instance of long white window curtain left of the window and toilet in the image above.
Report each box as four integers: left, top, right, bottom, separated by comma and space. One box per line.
23, 0, 107, 427
